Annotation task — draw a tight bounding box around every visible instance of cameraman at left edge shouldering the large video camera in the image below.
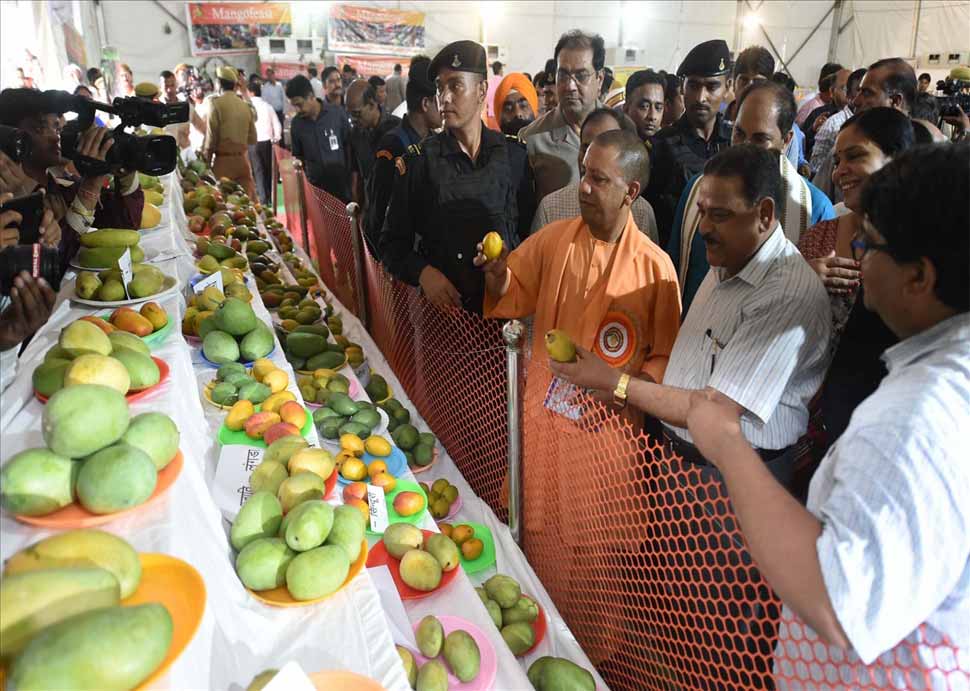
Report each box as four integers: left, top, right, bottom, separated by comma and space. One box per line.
0, 89, 145, 273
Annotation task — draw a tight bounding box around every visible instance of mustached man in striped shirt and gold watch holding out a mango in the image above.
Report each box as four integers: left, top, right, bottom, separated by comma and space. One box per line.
551, 144, 831, 484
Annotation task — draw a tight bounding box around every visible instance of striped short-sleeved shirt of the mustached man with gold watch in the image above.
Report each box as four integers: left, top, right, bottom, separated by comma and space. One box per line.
663, 223, 832, 449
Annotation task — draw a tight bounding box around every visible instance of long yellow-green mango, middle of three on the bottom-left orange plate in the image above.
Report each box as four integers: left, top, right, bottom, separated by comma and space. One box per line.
0, 568, 121, 659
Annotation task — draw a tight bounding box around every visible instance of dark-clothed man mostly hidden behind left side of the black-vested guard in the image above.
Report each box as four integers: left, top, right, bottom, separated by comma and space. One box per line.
364, 55, 441, 257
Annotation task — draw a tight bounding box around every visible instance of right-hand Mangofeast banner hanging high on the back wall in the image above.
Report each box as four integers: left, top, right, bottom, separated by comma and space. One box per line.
327, 5, 424, 55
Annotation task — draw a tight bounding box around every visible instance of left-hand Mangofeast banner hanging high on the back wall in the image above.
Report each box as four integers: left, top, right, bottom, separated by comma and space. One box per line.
185, 2, 293, 55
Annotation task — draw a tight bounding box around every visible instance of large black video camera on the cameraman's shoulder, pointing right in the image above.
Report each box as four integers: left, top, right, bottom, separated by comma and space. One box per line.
44, 91, 189, 177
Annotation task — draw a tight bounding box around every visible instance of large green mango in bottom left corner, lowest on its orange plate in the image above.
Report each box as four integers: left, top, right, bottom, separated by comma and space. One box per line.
7, 603, 172, 689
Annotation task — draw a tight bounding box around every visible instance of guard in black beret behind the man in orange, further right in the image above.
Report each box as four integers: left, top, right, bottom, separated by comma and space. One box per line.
644, 39, 731, 247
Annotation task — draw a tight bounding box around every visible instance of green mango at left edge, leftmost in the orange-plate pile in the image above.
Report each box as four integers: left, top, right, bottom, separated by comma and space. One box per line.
0, 448, 79, 516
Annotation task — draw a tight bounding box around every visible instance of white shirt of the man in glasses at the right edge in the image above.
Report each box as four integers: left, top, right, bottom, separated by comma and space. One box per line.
772, 312, 970, 689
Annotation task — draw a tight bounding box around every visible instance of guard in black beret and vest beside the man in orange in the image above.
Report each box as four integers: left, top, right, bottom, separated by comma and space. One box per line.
380, 41, 535, 314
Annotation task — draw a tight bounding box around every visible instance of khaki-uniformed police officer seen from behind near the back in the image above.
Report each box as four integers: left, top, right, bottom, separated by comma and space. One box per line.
202, 65, 256, 199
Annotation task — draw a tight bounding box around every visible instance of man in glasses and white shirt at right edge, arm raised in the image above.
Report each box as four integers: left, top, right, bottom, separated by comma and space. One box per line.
687, 145, 970, 689
